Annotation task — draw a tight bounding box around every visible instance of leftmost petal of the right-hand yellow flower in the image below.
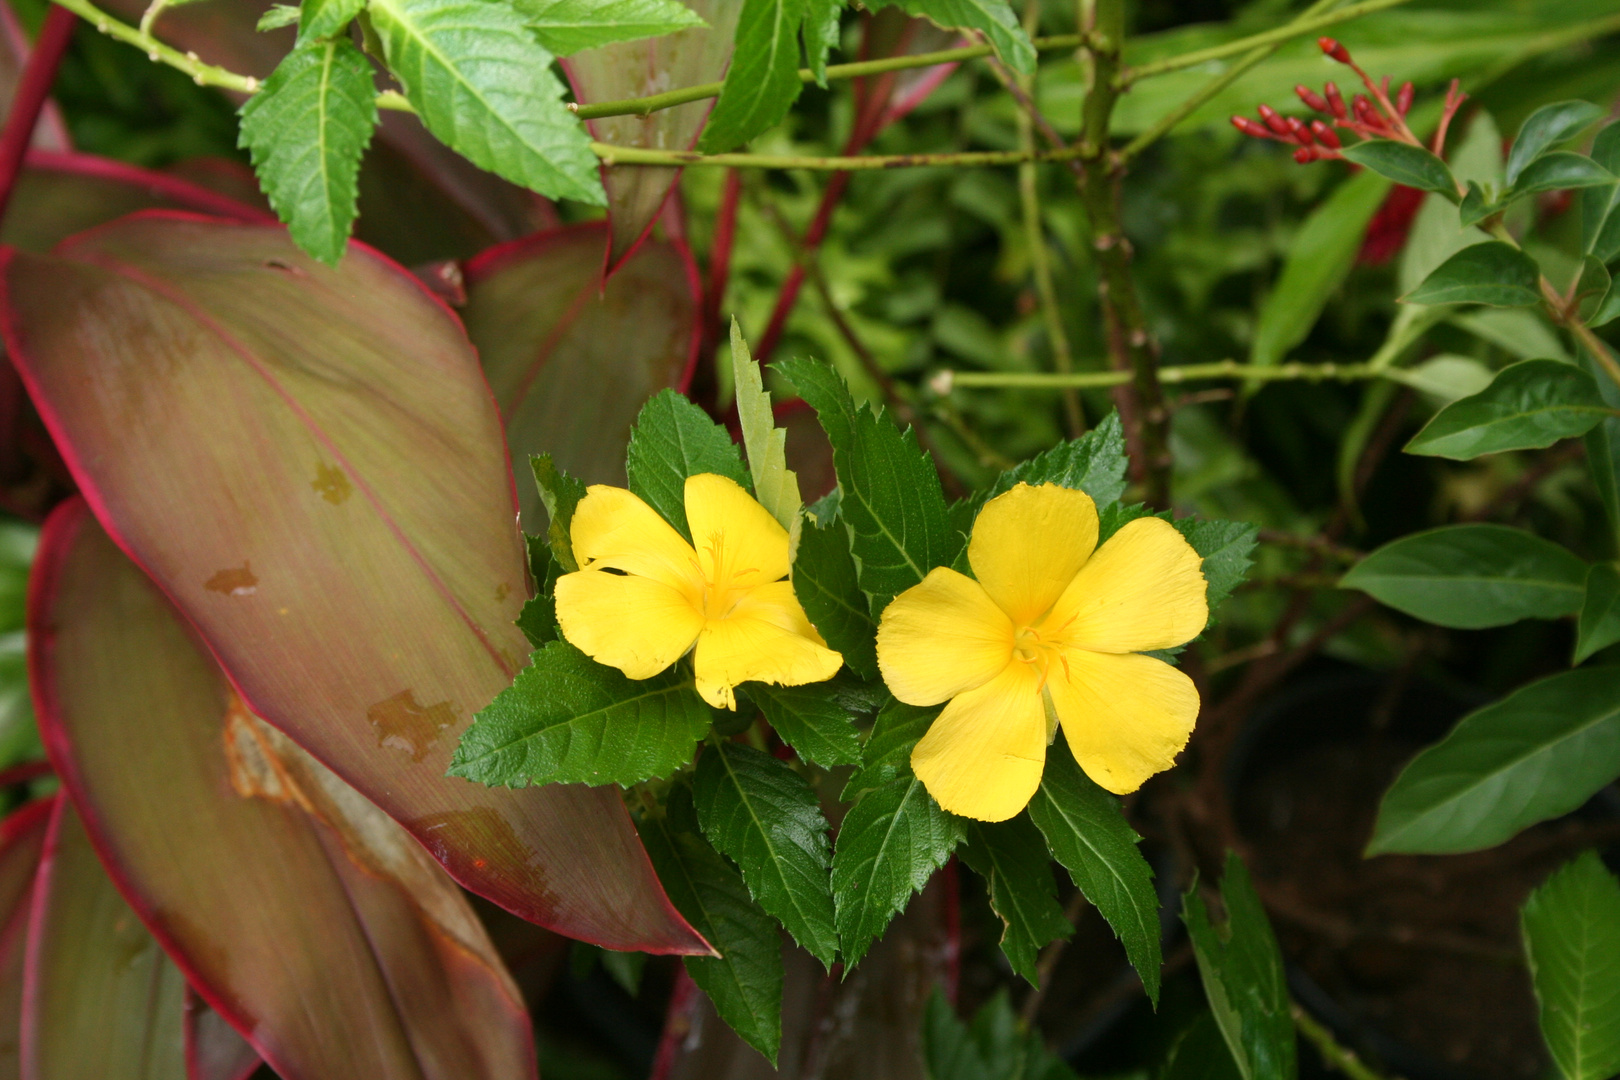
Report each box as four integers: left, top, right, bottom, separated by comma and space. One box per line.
878, 567, 1013, 704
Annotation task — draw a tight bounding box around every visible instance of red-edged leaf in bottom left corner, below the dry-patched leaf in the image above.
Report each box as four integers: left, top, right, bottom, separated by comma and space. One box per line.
23, 798, 186, 1080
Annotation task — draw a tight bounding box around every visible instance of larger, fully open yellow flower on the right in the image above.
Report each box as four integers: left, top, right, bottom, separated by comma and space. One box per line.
878, 484, 1209, 821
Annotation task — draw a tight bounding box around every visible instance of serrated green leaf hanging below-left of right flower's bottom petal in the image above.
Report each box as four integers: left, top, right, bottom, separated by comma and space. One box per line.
833, 776, 962, 972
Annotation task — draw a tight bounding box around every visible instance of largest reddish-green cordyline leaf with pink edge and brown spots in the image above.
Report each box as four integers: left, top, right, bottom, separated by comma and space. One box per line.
0, 215, 703, 952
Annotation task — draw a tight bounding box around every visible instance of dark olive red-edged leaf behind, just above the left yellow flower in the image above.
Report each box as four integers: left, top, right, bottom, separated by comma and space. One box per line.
462, 222, 698, 533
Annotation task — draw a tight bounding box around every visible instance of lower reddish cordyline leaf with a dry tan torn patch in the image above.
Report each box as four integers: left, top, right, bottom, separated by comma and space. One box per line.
31, 500, 535, 1080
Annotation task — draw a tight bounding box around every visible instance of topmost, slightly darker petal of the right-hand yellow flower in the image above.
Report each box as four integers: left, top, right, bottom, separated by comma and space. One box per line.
967, 484, 1097, 627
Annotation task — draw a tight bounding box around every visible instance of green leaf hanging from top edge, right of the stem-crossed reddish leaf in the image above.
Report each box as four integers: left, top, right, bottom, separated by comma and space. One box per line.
698, 0, 807, 154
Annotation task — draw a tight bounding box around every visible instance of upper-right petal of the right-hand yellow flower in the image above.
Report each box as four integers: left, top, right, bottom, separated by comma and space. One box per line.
1043, 518, 1210, 653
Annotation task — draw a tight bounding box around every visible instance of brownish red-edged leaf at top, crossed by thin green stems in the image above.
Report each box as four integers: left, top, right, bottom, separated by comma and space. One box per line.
562, 0, 742, 274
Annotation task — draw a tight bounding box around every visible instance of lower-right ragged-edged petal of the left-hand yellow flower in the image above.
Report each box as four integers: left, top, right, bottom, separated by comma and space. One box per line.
692, 581, 844, 709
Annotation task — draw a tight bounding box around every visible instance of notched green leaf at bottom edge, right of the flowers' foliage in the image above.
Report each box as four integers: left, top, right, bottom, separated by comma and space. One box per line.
1181, 852, 1299, 1080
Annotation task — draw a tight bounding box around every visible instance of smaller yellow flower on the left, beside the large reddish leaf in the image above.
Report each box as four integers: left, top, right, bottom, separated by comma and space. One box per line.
556, 473, 844, 709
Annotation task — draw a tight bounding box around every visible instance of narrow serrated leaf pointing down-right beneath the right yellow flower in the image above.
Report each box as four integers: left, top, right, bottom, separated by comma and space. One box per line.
1029, 746, 1163, 1002
